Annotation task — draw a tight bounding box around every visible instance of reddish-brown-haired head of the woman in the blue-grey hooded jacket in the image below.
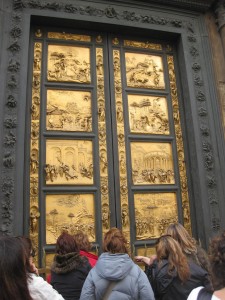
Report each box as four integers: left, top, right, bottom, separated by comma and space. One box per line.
103, 227, 128, 253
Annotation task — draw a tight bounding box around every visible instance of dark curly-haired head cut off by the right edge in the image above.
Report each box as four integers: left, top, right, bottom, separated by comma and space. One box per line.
209, 231, 225, 290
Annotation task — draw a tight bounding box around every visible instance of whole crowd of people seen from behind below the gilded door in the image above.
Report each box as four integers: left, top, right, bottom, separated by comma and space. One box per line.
0, 223, 225, 300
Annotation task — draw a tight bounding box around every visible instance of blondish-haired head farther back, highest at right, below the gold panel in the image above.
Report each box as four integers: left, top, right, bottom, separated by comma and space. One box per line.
165, 223, 197, 254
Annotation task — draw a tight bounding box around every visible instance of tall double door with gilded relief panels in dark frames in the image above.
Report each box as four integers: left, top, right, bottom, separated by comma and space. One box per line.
29, 29, 191, 261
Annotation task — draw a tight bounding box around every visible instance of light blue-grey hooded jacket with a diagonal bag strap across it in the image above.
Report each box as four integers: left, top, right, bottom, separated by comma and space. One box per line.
80, 252, 155, 300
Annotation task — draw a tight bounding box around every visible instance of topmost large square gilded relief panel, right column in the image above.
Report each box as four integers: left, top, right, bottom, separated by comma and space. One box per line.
125, 53, 165, 89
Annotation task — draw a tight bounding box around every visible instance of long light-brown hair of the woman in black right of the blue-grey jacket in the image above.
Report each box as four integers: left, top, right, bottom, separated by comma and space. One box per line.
156, 235, 190, 282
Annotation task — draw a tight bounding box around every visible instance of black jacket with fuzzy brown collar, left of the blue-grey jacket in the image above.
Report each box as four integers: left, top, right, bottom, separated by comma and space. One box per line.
50, 253, 91, 300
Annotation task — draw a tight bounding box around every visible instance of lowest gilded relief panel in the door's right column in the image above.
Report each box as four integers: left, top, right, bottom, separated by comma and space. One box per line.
134, 193, 178, 240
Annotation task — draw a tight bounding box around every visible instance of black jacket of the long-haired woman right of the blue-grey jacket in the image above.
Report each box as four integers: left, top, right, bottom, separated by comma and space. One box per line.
146, 260, 211, 300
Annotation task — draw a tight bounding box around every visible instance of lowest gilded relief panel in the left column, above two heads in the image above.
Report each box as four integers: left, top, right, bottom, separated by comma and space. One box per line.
46, 194, 95, 244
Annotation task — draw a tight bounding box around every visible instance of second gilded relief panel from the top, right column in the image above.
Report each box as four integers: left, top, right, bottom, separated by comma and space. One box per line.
128, 95, 169, 134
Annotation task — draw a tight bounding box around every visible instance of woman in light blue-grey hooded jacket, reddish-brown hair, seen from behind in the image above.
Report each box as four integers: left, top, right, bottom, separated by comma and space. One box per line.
80, 228, 155, 300
